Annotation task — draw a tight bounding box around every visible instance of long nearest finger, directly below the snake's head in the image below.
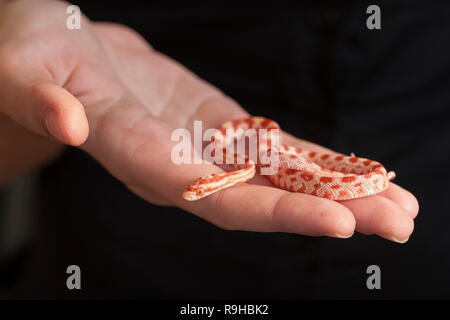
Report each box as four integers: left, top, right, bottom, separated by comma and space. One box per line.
188, 184, 355, 238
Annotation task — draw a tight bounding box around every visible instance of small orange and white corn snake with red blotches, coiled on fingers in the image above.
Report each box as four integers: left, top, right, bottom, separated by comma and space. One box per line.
183, 117, 395, 201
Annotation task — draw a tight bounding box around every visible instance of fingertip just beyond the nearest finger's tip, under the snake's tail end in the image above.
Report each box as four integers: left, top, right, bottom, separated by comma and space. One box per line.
339, 195, 414, 243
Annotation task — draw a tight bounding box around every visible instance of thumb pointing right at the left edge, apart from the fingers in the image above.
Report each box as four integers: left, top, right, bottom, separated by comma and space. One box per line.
0, 82, 89, 146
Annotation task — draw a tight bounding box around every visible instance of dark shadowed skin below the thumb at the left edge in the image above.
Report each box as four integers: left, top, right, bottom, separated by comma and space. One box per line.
0, 114, 63, 186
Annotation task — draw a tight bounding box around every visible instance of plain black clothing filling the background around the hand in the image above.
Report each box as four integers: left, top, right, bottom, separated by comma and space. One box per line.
9, 0, 450, 298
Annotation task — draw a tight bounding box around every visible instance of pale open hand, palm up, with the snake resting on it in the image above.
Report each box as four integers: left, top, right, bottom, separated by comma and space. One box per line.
0, 0, 419, 242
